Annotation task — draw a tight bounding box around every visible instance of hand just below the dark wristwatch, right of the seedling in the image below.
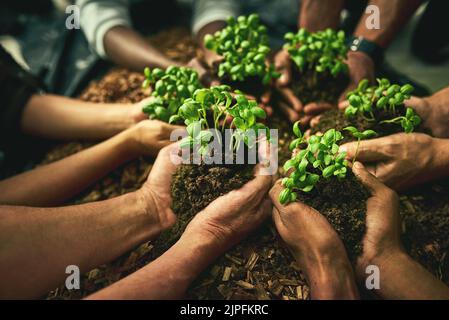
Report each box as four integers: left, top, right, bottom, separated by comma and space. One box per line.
338, 51, 375, 109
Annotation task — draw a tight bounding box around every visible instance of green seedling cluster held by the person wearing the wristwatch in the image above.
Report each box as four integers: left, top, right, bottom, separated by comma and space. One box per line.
284, 29, 348, 77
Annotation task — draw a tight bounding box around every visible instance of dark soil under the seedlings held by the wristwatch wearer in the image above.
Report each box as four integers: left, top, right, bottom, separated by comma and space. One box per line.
291, 63, 349, 105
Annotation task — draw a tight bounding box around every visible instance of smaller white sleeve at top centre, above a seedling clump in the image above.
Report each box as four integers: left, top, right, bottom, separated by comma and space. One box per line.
192, 0, 239, 34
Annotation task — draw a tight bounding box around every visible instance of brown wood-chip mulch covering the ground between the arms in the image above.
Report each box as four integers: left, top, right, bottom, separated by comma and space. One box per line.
42, 28, 449, 300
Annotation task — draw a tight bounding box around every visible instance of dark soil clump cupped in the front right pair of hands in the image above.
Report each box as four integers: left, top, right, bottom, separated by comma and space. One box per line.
298, 170, 369, 262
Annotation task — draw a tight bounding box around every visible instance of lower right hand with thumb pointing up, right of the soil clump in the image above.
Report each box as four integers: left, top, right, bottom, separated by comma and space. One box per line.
352, 162, 403, 274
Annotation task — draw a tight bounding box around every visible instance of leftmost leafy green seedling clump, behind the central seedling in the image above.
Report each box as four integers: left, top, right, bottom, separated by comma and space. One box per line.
142, 66, 202, 122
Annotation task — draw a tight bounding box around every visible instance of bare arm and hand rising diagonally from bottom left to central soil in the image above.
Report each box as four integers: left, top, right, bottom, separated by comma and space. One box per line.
89, 151, 271, 299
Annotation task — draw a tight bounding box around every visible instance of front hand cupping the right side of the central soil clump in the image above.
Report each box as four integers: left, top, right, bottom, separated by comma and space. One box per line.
183, 164, 272, 255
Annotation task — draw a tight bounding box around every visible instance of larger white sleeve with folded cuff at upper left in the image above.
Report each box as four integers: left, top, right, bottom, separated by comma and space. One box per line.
76, 0, 131, 58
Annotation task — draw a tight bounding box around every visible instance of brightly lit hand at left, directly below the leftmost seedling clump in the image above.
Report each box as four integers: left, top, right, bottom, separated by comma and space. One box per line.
124, 120, 184, 157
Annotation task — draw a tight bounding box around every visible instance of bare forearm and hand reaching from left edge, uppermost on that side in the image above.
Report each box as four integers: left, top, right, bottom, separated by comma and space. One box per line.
20, 94, 151, 140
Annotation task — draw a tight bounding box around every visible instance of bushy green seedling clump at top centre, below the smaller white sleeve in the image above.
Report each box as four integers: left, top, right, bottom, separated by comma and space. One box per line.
204, 14, 279, 85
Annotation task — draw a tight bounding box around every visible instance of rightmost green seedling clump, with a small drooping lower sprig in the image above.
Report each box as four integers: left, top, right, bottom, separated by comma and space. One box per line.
345, 79, 421, 133
